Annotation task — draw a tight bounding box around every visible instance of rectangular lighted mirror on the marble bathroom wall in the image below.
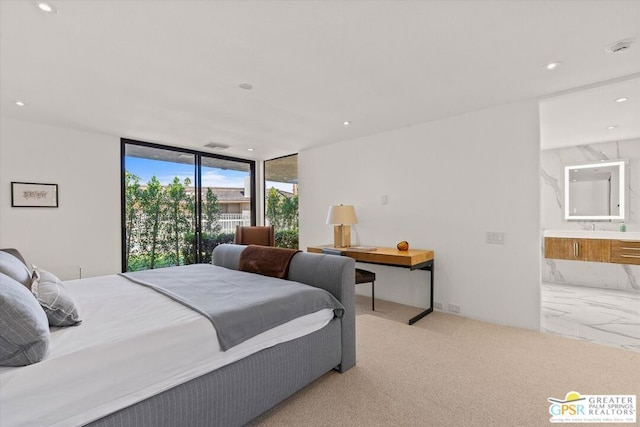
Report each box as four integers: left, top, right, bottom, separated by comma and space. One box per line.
564, 160, 626, 221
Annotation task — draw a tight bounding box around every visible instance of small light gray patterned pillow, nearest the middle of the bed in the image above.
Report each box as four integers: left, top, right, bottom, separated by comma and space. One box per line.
31, 266, 82, 326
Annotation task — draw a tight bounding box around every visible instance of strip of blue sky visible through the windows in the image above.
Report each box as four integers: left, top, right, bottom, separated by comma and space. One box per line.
125, 156, 293, 192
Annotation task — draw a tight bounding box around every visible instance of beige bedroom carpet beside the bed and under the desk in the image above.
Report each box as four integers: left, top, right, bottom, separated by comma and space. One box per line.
252, 301, 640, 426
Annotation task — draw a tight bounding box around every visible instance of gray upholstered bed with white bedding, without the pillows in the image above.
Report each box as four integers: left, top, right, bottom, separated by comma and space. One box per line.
0, 244, 355, 426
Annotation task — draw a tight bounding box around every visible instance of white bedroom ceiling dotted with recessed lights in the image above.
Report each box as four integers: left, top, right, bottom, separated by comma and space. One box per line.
0, 0, 640, 159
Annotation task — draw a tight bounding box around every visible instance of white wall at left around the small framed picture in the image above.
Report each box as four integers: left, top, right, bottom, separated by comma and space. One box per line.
0, 118, 121, 279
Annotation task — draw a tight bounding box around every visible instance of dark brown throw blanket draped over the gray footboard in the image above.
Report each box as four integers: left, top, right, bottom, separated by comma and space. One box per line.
239, 245, 300, 279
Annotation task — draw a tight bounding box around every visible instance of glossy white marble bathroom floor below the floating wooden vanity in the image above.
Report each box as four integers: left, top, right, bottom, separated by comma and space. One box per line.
540, 283, 640, 352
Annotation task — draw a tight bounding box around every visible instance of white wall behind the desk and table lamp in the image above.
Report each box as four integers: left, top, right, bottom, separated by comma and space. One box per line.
299, 101, 540, 330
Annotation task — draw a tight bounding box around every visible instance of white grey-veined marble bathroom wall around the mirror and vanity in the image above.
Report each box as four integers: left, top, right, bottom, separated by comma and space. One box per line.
540, 139, 640, 292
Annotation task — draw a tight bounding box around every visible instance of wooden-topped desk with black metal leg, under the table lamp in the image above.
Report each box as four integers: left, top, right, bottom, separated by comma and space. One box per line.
307, 245, 434, 325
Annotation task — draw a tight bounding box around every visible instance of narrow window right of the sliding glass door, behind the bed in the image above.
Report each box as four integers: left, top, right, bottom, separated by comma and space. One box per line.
264, 154, 299, 249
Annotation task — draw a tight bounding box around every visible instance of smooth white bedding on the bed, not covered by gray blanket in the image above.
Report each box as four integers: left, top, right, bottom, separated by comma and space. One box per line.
0, 275, 333, 427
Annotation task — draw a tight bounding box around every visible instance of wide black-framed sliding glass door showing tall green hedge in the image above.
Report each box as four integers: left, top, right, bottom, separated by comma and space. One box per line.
122, 139, 255, 271
